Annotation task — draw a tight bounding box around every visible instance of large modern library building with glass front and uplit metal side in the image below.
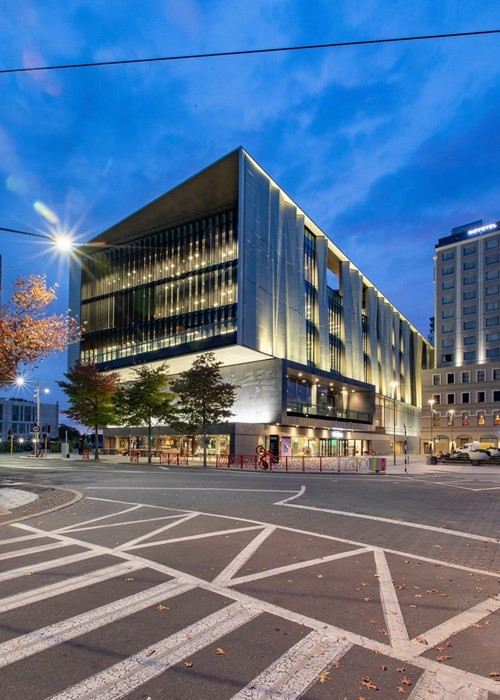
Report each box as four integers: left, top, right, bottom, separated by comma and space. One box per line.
70, 148, 433, 456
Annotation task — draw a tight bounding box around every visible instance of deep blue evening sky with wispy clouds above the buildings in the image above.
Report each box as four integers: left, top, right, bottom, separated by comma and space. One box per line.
0, 0, 500, 408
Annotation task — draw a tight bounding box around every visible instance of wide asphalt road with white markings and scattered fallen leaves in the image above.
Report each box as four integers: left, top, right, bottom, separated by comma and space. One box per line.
0, 460, 500, 700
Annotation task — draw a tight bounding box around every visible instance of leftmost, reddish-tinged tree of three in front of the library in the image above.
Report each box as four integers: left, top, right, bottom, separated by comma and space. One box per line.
57, 363, 120, 459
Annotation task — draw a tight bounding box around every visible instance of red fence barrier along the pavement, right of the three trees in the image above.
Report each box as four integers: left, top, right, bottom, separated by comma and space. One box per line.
215, 455, 372, 473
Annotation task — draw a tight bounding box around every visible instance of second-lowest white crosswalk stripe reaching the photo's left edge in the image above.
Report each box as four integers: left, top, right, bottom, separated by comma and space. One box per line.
0, 562, 140, 613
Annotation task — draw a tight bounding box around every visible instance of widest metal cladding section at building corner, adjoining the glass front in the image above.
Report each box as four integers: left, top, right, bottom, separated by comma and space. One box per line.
238, 153, 306, 364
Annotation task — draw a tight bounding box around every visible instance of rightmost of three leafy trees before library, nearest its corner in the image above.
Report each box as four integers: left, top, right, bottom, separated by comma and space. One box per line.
172, 352, 238, 467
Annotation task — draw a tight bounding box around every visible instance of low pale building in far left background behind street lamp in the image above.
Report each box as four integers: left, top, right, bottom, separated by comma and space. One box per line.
0, 397, 59, 442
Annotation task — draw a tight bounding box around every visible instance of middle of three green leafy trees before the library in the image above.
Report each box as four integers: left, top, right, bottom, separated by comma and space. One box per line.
116, 364, 176, 464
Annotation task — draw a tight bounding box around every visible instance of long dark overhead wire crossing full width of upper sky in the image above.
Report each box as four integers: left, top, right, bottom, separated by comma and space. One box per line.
0, 29, 500, 75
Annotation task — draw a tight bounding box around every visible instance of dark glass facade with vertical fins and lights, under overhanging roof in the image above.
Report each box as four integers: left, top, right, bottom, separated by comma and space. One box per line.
81, 209, 238, 362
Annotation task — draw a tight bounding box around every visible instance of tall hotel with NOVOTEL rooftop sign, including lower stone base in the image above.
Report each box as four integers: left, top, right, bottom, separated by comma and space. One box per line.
422, 221, 500, 452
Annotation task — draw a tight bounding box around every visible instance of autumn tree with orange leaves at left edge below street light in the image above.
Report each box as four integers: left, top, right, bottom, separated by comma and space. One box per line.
0, 275, 81, 385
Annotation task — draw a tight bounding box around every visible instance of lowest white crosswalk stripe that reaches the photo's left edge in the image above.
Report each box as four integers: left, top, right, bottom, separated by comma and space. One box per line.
0, 580, 194, 668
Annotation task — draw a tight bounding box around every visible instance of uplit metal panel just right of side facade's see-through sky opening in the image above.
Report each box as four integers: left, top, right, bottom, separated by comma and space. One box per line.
340, 262, 364, 381
